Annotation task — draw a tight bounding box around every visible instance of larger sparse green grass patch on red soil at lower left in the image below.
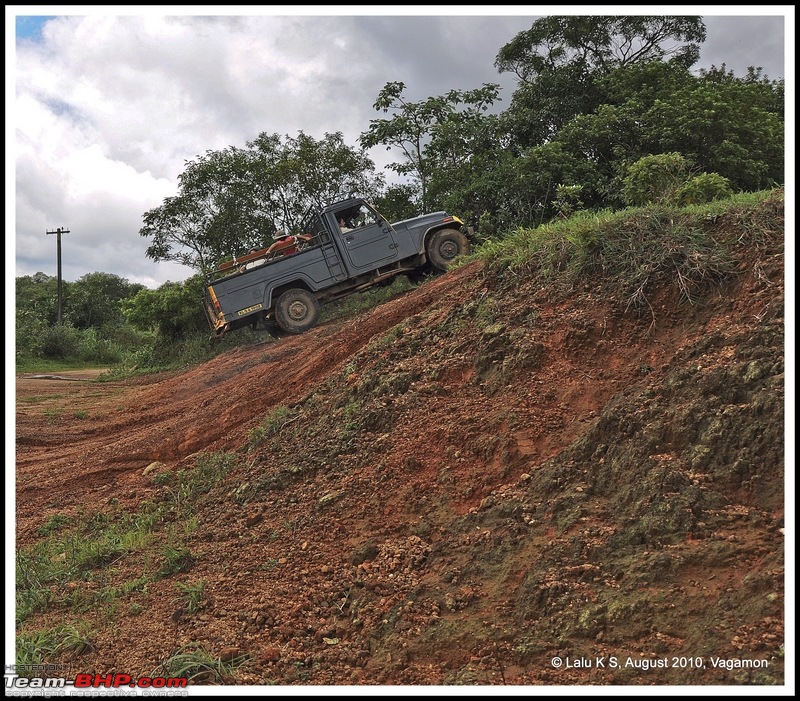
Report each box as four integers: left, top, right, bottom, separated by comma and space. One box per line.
16, 453, 236, 624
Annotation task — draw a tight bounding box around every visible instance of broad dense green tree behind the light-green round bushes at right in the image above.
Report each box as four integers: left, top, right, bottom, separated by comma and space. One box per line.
552, 61, 784, 208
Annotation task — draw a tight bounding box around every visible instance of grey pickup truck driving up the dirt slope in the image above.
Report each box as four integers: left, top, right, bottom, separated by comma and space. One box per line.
204, 198, 473, 336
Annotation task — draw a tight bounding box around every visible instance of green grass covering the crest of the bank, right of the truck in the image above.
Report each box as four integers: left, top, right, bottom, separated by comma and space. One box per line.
470, 190, 783, 309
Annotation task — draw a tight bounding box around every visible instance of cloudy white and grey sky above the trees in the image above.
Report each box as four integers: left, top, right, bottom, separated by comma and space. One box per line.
6, 5, 794, 288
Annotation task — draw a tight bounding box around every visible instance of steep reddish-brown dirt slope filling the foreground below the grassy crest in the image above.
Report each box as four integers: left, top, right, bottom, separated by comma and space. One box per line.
17, 194, 785, 685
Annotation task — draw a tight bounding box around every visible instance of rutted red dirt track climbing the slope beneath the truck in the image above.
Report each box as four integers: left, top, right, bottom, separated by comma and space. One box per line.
16, 270, 476, 543
